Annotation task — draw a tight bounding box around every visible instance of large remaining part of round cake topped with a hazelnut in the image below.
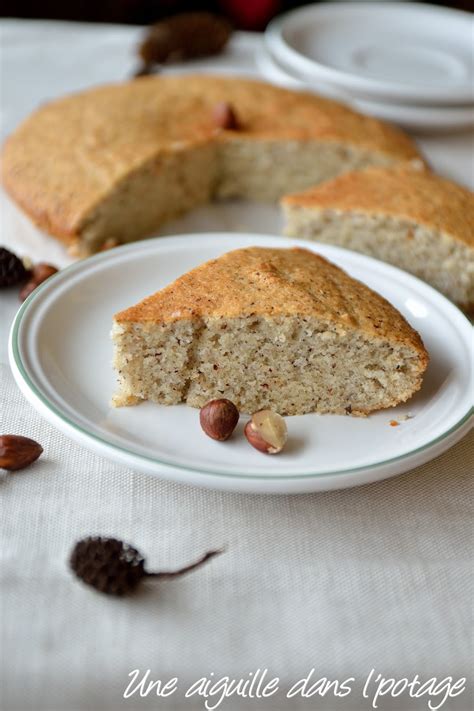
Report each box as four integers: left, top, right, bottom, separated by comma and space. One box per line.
2, 75, 419, 255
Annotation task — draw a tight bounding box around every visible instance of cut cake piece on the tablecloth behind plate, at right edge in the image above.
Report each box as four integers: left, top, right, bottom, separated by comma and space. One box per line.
282, 166, 474, 310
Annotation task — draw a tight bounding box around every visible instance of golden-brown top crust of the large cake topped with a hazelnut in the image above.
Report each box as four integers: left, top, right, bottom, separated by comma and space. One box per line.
3, 75, 419, 241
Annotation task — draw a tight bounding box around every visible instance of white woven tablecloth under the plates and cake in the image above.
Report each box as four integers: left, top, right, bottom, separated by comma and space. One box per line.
0, 21, 474, 711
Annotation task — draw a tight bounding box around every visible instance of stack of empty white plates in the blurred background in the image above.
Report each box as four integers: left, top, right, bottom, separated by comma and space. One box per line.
257, 2, 474, 130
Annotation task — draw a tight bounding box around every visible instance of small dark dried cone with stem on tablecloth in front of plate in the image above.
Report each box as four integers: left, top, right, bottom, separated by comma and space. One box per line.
69, 536, 221, 596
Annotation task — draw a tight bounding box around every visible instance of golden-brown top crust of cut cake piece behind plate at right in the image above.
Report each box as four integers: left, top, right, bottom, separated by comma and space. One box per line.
282, 166, 474, 246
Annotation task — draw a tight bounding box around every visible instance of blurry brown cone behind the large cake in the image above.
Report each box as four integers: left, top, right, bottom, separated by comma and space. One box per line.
139, 12, 232, 65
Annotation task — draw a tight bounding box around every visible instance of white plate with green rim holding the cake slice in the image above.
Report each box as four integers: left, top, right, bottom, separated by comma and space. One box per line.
9, 233, 473, 493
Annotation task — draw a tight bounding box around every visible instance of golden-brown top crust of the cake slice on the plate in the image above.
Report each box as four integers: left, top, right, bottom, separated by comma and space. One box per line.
115, 247, 428, 363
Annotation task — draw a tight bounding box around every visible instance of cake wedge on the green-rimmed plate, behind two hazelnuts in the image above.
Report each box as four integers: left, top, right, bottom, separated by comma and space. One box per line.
112, 247, 428, 415
